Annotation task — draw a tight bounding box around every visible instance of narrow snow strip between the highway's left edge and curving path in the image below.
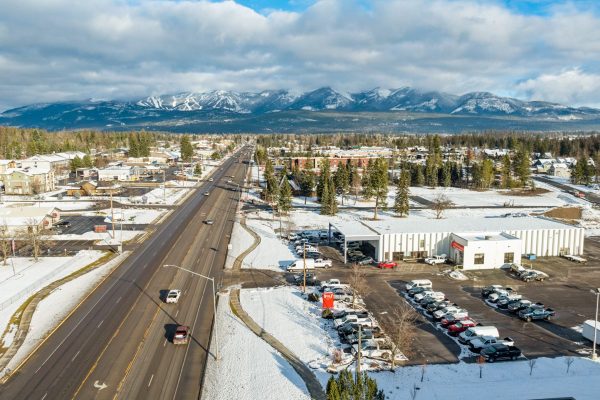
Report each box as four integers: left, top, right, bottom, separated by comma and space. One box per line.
0, 252, 129, 375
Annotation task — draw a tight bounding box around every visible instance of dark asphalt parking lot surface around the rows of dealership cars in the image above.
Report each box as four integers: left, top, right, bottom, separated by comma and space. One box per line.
304, 239, 600, 364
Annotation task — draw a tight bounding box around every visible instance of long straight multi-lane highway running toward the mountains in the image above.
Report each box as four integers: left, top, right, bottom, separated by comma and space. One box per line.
0, 147, 251, 400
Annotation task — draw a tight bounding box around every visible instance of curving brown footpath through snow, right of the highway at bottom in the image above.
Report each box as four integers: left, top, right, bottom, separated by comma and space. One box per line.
229, 289, 327, 400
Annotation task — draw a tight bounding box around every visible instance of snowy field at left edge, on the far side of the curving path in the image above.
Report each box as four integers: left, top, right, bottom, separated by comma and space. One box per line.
0, 250, 104, 346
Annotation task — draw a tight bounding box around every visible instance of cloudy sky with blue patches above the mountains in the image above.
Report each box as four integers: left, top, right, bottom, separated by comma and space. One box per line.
0, 0, 600, 110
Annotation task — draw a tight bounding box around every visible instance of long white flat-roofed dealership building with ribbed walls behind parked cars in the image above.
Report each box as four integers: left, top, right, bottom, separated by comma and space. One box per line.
329, 216, 585, 269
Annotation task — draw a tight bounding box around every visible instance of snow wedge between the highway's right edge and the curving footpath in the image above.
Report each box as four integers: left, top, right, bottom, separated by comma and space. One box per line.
202, 295, 310, 400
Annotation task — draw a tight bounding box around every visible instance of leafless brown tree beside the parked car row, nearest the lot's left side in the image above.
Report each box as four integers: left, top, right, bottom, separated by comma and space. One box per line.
382, 302, 426, 372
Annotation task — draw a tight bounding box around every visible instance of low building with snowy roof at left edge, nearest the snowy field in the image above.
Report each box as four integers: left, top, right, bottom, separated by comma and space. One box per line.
0, 206, 60, 233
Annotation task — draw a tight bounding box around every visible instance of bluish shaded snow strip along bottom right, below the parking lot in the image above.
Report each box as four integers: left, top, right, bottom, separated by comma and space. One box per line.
354, 357, 600, 400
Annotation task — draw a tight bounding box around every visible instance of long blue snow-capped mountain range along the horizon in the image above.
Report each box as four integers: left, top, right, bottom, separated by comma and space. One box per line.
0, 87, 600, 131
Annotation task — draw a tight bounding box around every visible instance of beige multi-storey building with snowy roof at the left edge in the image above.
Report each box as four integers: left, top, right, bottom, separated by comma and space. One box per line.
0, 167, 55, 195
